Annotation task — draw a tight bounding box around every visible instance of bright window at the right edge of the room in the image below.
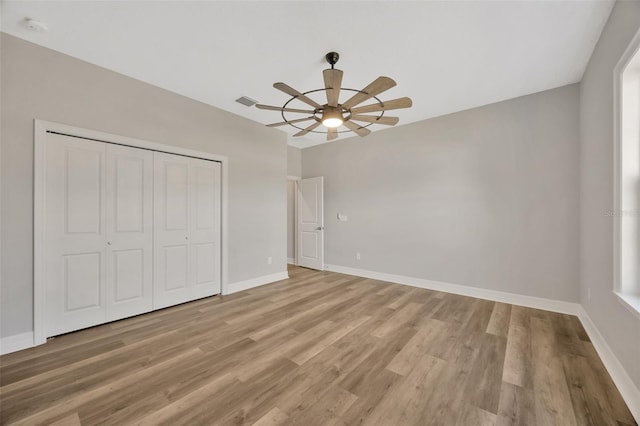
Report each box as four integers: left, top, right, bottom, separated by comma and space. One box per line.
612, 28, 640, 316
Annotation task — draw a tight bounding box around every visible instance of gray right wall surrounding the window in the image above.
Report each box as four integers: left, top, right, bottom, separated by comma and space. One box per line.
580, 2, 640, 388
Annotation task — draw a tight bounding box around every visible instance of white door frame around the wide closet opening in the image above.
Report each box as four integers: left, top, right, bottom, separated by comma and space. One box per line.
33, 119, 229, 346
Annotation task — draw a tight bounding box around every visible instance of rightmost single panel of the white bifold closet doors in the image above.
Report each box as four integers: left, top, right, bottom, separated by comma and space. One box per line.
189, 158, 221, 299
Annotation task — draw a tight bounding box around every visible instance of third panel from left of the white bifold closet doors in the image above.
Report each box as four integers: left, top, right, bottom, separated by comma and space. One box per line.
153, 152, 191, 309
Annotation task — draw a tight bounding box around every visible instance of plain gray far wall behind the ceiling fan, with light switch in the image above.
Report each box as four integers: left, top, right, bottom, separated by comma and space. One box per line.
302, 85, 579, 302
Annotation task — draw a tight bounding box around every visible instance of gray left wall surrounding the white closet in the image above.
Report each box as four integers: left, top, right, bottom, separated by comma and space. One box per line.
0, 34, 288, 336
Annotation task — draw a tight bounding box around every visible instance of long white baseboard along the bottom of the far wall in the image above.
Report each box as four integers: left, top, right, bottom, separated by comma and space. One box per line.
327, 265, 581, 315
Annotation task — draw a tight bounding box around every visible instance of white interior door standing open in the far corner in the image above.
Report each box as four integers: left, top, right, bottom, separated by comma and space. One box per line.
297, 176, 324, 271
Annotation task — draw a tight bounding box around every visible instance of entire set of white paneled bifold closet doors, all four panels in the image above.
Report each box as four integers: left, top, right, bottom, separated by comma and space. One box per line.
44, 133, 221, 336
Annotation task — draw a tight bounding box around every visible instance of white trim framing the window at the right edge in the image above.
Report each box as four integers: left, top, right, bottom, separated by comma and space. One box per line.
612, 26, 640, 315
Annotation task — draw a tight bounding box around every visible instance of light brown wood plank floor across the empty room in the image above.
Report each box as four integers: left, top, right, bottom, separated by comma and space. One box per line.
0, 267, 636, 426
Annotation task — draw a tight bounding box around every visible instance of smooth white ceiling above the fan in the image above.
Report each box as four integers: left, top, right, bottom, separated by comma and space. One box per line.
2, 0, 613, 147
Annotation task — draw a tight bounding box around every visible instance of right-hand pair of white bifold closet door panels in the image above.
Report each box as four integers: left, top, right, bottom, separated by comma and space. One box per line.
153, 153, 221, 309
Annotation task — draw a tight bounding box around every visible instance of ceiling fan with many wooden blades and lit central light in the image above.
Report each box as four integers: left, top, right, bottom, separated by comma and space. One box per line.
256, 52, 413, 141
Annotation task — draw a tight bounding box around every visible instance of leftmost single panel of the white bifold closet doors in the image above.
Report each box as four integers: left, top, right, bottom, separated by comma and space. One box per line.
44, 133, 106, 336
